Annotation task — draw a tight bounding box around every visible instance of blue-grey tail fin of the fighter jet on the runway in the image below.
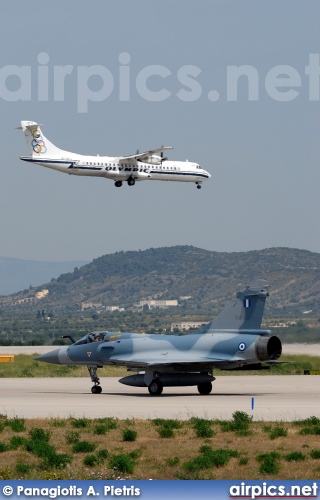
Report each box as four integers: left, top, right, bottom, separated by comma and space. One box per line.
205, 279, 269, 332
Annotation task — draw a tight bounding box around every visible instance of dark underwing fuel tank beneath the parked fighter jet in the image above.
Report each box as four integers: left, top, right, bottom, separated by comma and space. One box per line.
119, 373, 215, 387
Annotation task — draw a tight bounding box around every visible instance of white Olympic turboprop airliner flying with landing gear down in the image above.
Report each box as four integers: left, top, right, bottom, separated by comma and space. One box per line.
18, 121, 211, 189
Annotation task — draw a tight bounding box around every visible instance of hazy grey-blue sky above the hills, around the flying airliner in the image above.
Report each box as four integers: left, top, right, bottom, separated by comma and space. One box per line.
0, 0, 320, 261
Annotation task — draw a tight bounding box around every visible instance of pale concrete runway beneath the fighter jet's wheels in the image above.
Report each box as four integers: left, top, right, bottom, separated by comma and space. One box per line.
0, 375, 320, 421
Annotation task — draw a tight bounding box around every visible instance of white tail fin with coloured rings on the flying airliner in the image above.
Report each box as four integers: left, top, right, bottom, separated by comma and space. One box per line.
18, 121, 62, 158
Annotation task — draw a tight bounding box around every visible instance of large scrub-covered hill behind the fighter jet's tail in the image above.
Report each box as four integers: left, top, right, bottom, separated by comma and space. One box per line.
0, 246, 320, 316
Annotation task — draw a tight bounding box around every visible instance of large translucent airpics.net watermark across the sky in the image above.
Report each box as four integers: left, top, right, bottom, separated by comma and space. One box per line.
0, 52, 320, 113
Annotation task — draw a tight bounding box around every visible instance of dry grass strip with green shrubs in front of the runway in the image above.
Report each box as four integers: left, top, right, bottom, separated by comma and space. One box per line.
0, 412, 320, 480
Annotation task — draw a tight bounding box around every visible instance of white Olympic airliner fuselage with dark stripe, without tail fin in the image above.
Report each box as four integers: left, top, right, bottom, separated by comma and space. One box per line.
21, 153, 210, 183
